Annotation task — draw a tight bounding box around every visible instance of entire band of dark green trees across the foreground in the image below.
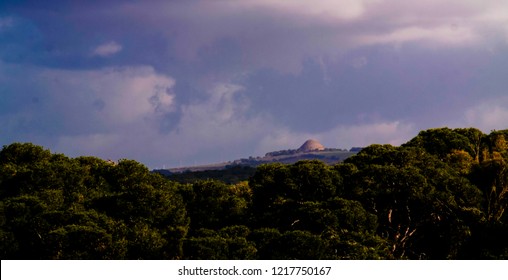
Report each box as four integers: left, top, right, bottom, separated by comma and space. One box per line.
0, 128, 508, 260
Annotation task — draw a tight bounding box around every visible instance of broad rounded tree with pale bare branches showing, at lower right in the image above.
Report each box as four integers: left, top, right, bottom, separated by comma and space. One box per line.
346, 145, 481, 258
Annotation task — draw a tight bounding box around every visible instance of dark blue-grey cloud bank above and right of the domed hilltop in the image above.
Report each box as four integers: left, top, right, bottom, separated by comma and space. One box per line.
247, 47, 494, 131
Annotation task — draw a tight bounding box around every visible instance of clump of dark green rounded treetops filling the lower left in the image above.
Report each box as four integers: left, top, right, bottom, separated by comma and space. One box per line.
0, 143, 188, 259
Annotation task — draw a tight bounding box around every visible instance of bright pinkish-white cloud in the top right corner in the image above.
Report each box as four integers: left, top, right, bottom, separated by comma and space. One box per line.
355, 0, 508, 47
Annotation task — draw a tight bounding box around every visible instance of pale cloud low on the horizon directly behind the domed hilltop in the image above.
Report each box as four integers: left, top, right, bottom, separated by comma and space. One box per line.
159, 84, 416, 166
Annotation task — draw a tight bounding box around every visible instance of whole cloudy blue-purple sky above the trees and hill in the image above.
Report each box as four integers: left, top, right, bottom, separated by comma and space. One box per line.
0, 0, 508, 168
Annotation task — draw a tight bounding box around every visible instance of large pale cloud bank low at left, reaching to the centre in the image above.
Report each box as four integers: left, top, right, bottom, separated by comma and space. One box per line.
0, 61, 277, 168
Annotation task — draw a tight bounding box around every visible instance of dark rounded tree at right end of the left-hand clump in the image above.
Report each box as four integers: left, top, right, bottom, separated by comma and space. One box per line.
90, 164, 189, 259
